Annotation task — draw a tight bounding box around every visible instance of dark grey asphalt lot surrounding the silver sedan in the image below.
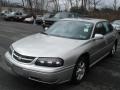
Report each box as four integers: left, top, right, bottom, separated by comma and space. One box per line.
0, 21, 120, 90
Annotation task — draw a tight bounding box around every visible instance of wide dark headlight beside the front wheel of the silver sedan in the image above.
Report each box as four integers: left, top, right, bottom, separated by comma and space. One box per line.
35, 57, 64, 67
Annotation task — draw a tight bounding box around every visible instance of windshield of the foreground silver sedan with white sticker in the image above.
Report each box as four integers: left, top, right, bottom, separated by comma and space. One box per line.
45, 21, 94, 40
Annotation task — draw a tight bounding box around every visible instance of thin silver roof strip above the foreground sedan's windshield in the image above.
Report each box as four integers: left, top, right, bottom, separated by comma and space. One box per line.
62, 18, 107, 24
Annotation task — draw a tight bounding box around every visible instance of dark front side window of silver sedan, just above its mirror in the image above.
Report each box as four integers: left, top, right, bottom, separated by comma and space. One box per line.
94, 23, 106, 35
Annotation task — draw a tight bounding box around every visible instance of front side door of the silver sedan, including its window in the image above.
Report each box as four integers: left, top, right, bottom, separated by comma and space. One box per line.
91, 22, 106, 63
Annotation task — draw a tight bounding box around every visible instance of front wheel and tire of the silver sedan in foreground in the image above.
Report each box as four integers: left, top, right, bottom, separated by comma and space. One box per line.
72, 57, 87, 84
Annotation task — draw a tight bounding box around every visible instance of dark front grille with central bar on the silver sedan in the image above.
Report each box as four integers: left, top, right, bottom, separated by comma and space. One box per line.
13, 51, 35, 63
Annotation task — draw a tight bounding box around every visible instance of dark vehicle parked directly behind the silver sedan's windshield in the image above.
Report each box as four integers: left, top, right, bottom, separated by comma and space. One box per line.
42, 12, 79, 27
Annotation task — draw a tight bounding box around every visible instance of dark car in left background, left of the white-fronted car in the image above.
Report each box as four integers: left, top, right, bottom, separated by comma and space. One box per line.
4, 12, 27, 21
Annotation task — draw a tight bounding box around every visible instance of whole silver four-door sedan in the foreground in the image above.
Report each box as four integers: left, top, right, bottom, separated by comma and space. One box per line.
5, 18, 118, 84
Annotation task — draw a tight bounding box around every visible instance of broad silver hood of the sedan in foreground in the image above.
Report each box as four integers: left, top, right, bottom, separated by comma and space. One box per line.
12, 33, 86, 57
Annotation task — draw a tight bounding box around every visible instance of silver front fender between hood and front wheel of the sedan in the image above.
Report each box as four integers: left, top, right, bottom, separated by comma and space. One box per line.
62, 40, 93, 67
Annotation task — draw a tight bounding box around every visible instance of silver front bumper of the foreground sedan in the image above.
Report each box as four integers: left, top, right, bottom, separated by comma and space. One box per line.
5, 52, 74, 84
